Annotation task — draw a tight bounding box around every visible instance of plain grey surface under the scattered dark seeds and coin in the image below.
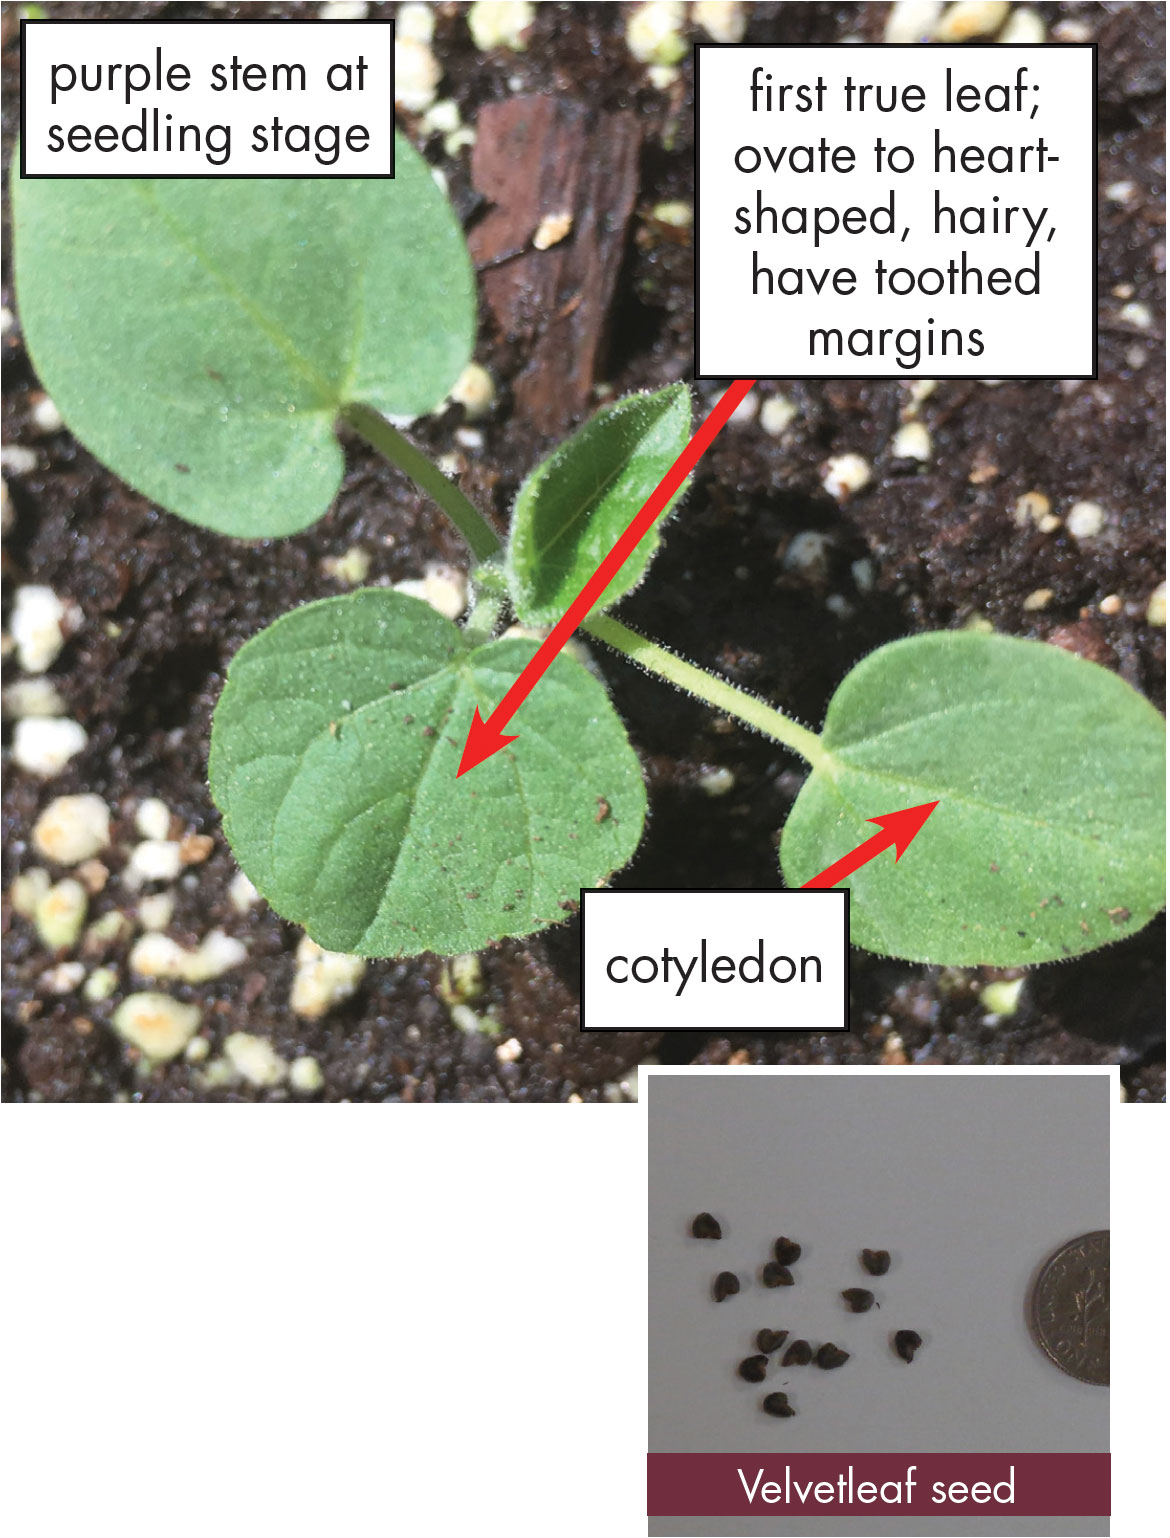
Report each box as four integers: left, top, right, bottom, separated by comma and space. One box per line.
647, 1074, 1109, 1455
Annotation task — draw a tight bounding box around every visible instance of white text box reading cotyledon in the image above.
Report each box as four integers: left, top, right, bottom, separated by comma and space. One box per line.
583, 889, 849, 1030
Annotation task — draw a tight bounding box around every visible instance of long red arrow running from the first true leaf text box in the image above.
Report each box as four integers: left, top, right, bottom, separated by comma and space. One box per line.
455, 380, 755, 780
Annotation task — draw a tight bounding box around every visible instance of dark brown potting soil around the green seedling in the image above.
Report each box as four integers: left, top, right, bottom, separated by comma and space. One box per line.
3, 5, 1165, 1101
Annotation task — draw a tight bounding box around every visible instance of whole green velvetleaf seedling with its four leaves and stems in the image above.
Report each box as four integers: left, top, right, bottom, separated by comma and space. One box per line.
12, 137, 1165, 966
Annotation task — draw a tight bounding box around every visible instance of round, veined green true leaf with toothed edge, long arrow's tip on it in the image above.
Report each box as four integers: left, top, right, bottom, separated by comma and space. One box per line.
211, 588, 646, 957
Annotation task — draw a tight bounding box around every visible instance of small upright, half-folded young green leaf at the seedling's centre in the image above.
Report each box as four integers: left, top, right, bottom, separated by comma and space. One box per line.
507, 385, 690, 624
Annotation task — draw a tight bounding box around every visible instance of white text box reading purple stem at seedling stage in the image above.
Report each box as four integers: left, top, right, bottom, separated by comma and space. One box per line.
23, 20, 394, 177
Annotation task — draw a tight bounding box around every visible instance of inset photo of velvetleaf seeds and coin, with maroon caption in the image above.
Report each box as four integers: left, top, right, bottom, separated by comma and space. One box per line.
644, 1069, 1116, 1535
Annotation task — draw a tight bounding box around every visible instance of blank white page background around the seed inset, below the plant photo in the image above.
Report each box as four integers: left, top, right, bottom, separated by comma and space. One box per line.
0, 1067, 1168, 1538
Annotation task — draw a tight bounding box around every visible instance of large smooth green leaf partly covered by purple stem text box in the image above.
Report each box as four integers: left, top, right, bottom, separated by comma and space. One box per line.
12, 135, 475, 538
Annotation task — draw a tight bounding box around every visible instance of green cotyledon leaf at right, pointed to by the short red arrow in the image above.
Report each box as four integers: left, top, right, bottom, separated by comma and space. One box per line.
779, 631, 1165, 966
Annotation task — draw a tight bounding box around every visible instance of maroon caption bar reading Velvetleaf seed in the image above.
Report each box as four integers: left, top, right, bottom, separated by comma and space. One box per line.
646, 1452, 1110, 1516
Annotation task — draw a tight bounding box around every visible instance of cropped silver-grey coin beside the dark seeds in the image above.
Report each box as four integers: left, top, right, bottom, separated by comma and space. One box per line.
1030, 1229, 1109, 1383
